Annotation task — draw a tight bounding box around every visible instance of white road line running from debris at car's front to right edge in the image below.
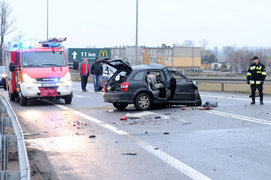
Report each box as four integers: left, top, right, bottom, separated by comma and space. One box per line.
205, 110, 271, 125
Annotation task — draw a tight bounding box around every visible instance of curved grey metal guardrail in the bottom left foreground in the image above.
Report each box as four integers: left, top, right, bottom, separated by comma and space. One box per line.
0, 96, 30, 180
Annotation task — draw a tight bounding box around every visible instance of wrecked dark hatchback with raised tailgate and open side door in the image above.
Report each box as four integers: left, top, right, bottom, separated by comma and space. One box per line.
102, 60, 202, 111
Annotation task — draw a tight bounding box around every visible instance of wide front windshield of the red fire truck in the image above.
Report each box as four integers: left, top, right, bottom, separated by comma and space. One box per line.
22, 51, 67, 68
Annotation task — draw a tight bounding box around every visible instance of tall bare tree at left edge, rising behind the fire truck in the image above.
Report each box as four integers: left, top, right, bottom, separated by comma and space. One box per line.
0, 0, 16, 64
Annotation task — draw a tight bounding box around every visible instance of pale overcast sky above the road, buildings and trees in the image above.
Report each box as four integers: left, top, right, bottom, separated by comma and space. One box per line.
5, 0, 271, 49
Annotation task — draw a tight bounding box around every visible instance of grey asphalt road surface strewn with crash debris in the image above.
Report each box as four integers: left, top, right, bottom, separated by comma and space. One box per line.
0, 82, 271, 180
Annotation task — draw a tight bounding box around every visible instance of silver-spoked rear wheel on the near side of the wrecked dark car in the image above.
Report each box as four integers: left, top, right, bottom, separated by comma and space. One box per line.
135, 93, 152, 111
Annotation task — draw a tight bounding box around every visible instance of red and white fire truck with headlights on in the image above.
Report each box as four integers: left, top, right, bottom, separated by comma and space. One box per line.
5, 38, 78, 106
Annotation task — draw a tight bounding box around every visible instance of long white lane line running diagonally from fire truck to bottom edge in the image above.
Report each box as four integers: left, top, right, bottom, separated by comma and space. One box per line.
55, 105, 211, 180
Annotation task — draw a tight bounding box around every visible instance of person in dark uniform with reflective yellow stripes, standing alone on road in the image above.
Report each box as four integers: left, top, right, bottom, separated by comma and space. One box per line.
247, 56, 266, 105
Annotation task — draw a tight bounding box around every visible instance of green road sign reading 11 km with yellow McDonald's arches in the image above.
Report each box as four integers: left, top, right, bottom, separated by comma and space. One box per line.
68, 48, 111, 62
